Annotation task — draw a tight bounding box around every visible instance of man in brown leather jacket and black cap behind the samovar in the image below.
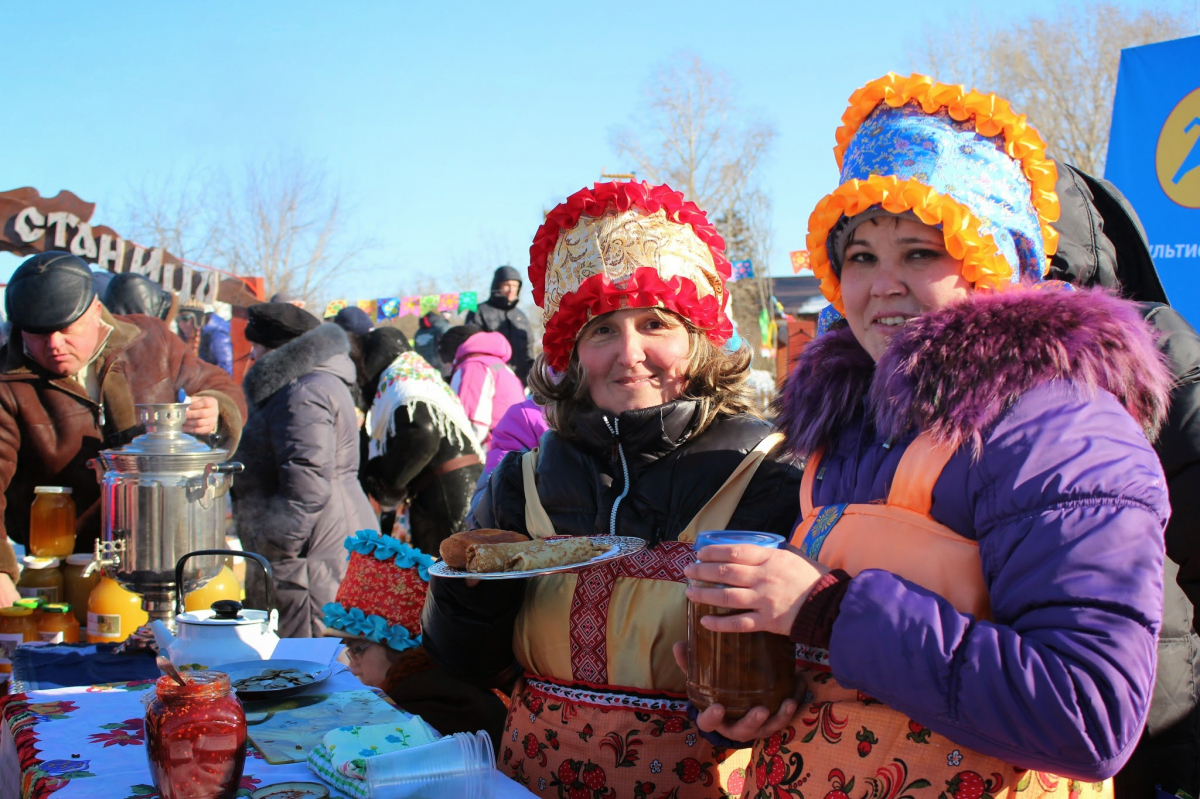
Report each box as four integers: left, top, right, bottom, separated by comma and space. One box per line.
0, 252, 246, 606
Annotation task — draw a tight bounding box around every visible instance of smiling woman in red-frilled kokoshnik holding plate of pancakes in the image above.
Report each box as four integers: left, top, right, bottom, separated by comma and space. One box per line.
424, 182, 799, 799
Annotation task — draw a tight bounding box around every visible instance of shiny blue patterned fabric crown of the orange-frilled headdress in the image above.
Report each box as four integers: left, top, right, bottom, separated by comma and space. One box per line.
830, 102, 1045, 283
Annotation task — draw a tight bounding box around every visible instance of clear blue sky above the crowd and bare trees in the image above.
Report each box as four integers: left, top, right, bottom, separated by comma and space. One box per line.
0, 0, 1180, 304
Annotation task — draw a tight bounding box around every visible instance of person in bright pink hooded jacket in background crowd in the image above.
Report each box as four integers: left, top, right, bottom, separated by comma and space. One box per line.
450, 332, 524, 449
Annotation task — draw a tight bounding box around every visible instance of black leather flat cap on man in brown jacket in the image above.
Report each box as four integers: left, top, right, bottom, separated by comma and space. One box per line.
4, 251, 96, 335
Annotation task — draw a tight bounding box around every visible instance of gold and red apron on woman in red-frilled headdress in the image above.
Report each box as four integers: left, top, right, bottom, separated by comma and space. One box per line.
497, 434, 781, 799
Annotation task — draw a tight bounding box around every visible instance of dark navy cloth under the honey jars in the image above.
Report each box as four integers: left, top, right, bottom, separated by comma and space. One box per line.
10, 644, 162, 693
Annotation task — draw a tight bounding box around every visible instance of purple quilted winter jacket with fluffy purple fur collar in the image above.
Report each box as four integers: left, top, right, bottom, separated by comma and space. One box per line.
780, 289, 1170, 780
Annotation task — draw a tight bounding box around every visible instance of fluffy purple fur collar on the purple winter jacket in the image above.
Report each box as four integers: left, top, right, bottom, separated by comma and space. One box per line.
776, 288, 1171, 456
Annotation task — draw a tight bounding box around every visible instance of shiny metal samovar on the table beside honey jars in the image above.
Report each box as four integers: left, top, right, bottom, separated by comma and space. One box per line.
92, 403, 241, 630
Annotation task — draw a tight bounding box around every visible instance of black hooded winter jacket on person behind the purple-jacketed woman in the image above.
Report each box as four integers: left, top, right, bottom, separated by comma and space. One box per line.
1048, 164, 1200, 799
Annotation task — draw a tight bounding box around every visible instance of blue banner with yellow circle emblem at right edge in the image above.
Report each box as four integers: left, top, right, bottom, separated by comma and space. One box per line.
1104, 36, 1200, 326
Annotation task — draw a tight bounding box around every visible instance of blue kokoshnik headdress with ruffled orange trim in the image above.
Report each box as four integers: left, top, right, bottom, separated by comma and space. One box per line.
808, 73, 1058, 312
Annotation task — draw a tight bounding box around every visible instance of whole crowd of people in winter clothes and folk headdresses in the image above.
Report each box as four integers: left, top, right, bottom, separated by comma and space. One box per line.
0, 69, 1200, 799
